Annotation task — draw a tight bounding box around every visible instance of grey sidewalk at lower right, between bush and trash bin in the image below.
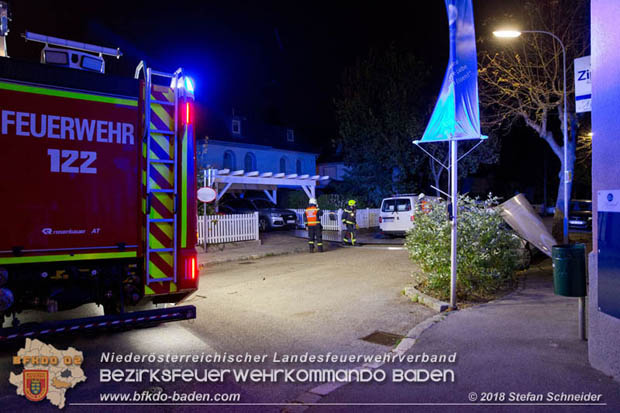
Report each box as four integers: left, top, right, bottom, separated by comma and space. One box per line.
311, 259, 620, 412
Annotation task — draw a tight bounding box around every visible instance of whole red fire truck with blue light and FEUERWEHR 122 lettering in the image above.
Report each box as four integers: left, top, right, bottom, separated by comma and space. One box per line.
0, 21, 198, 342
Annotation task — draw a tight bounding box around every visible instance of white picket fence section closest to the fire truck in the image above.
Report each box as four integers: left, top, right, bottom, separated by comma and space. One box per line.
198, 212, 259, 244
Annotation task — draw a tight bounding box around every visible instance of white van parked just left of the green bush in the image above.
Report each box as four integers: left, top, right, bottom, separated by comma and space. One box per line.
379, 194, 437, 235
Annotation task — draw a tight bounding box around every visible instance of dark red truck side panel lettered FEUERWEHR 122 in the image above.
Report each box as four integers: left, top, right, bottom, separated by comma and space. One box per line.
0, 58, 141, 256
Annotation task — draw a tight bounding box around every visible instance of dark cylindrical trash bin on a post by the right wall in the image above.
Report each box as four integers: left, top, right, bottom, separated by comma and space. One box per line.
551, 244, 586, 297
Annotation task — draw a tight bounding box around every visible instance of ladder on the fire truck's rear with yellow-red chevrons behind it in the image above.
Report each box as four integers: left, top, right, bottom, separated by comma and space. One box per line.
145, 67, 182, 286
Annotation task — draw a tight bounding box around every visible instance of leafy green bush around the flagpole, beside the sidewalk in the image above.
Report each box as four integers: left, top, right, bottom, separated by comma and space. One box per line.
405, 195, 520, 301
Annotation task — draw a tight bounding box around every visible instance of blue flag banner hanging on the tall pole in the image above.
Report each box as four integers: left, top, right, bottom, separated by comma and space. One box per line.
419, 0, 486, 142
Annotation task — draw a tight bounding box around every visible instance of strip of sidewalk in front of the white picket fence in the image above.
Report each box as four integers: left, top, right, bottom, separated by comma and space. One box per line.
197, 232, 322, 267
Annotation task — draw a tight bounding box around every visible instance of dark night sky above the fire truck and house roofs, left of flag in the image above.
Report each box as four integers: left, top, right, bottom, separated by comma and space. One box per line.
8, 0, 515, 142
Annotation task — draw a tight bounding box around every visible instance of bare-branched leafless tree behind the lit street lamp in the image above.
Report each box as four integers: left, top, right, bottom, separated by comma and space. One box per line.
479, 0, 589, 210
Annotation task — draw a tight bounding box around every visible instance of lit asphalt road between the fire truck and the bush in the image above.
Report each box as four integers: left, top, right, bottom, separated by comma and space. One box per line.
0, 246, 434, 411
